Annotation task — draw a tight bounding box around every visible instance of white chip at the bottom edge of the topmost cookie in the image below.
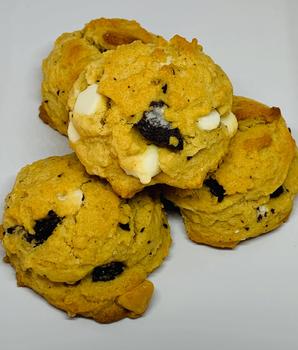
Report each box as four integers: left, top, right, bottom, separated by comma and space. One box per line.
123, 146, 160, 184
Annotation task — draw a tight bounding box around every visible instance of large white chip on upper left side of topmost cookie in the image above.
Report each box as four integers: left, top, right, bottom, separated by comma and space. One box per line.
74, 84, 106, 115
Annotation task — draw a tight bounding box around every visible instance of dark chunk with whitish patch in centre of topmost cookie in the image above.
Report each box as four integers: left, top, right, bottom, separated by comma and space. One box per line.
136, 101, 183, 151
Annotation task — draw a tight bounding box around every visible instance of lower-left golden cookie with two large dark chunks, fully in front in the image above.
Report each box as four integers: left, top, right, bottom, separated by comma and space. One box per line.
2, 154, 171, 323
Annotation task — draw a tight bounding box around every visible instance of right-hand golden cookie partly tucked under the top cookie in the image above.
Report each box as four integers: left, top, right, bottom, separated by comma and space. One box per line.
164, 97, 298, 248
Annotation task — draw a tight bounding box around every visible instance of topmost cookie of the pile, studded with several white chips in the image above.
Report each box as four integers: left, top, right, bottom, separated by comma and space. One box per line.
68, 35, 237, 198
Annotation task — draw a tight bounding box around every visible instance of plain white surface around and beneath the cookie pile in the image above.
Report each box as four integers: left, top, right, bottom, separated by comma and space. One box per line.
0, 0, 298, 350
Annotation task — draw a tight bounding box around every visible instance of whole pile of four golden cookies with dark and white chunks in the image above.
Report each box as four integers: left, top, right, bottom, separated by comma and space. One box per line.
1, 18, 298, 323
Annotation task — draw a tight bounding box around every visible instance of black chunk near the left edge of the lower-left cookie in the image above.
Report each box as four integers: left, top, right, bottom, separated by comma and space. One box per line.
24, 210, 61, 246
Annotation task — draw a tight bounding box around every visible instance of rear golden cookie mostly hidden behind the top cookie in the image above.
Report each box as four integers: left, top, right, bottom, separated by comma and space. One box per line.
39, 18, 161, 135
